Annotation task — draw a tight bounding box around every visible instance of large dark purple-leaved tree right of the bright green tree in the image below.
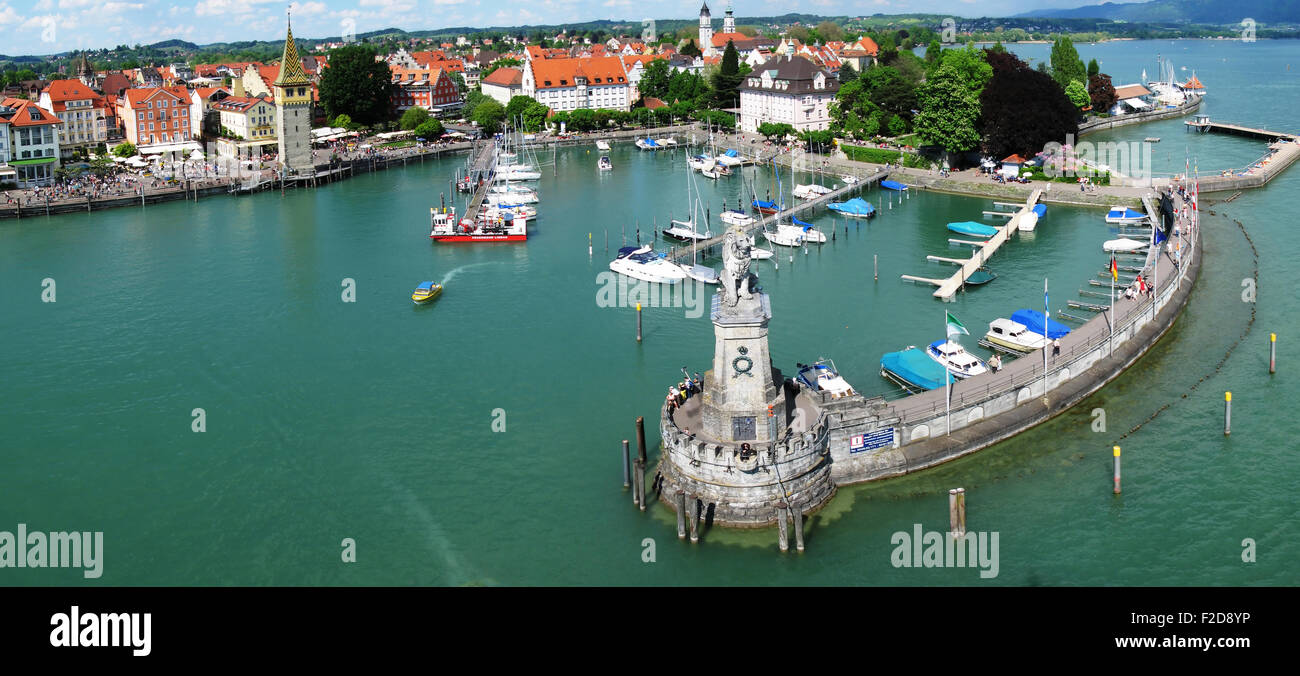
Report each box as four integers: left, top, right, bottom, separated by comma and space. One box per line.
980, 68, 1079, 157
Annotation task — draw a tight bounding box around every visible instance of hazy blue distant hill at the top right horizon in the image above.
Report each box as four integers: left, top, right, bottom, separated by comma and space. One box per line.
1018, 0, 1300, 26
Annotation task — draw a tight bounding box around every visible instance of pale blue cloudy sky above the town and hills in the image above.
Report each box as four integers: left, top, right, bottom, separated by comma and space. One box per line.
0, 0, 1118, 56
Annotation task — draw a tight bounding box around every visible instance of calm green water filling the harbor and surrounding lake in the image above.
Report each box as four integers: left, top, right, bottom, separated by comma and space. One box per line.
0, 42, 1300, 585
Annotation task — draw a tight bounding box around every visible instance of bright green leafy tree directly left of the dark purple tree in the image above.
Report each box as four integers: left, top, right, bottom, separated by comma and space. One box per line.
913, 64, 977, 152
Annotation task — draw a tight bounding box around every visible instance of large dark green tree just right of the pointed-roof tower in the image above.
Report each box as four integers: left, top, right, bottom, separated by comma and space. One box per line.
320, 44, 393, 125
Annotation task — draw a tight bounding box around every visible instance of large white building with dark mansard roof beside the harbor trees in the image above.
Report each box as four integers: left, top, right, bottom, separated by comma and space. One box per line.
737, 56, 840, 133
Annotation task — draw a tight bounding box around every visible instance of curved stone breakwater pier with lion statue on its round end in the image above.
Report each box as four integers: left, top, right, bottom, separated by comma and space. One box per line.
653, 188, 1201, 527
